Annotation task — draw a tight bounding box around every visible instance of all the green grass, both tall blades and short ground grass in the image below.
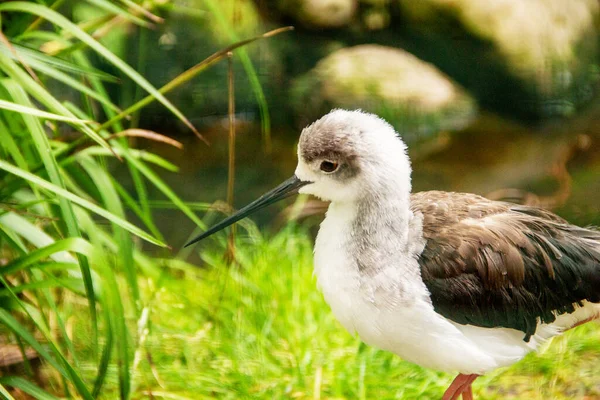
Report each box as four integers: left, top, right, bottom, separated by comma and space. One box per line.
0, 0, 600, 400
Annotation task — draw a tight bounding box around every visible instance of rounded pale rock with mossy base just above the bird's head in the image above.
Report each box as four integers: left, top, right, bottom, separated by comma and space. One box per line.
292, 45, 476, 142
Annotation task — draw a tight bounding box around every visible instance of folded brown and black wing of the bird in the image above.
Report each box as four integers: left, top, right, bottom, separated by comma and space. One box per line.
412, 192, 600, 341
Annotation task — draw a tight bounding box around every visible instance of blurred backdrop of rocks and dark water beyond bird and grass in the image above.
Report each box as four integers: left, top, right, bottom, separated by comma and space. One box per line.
113, 0, 600, 244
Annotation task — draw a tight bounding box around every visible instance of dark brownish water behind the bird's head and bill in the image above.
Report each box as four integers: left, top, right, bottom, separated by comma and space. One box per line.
115, 103, 600, 248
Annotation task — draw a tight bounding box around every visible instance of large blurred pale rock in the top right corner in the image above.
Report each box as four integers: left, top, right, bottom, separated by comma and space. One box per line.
398, 0, 600, 116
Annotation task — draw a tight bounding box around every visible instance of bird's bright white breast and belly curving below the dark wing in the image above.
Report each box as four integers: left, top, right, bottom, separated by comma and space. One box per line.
315, 205, 589, 374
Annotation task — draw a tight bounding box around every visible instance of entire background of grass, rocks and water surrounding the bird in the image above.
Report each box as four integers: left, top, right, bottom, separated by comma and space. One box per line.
0, 0, 600, 399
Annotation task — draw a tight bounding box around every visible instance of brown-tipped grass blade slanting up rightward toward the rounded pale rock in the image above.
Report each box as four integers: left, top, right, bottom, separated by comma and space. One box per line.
99, 26, 293, 137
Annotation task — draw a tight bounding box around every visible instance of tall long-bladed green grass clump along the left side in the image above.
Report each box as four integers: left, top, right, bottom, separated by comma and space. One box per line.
0, 0, 285, 399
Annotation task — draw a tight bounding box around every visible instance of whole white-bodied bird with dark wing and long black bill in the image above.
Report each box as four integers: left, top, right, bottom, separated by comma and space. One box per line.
186, 109, 600, 400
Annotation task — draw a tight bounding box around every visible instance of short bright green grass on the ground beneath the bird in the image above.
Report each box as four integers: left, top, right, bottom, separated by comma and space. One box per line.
55, 227, 600, 399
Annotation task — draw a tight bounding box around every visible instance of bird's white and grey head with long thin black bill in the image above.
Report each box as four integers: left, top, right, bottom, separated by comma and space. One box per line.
186, 110, 410, 246
